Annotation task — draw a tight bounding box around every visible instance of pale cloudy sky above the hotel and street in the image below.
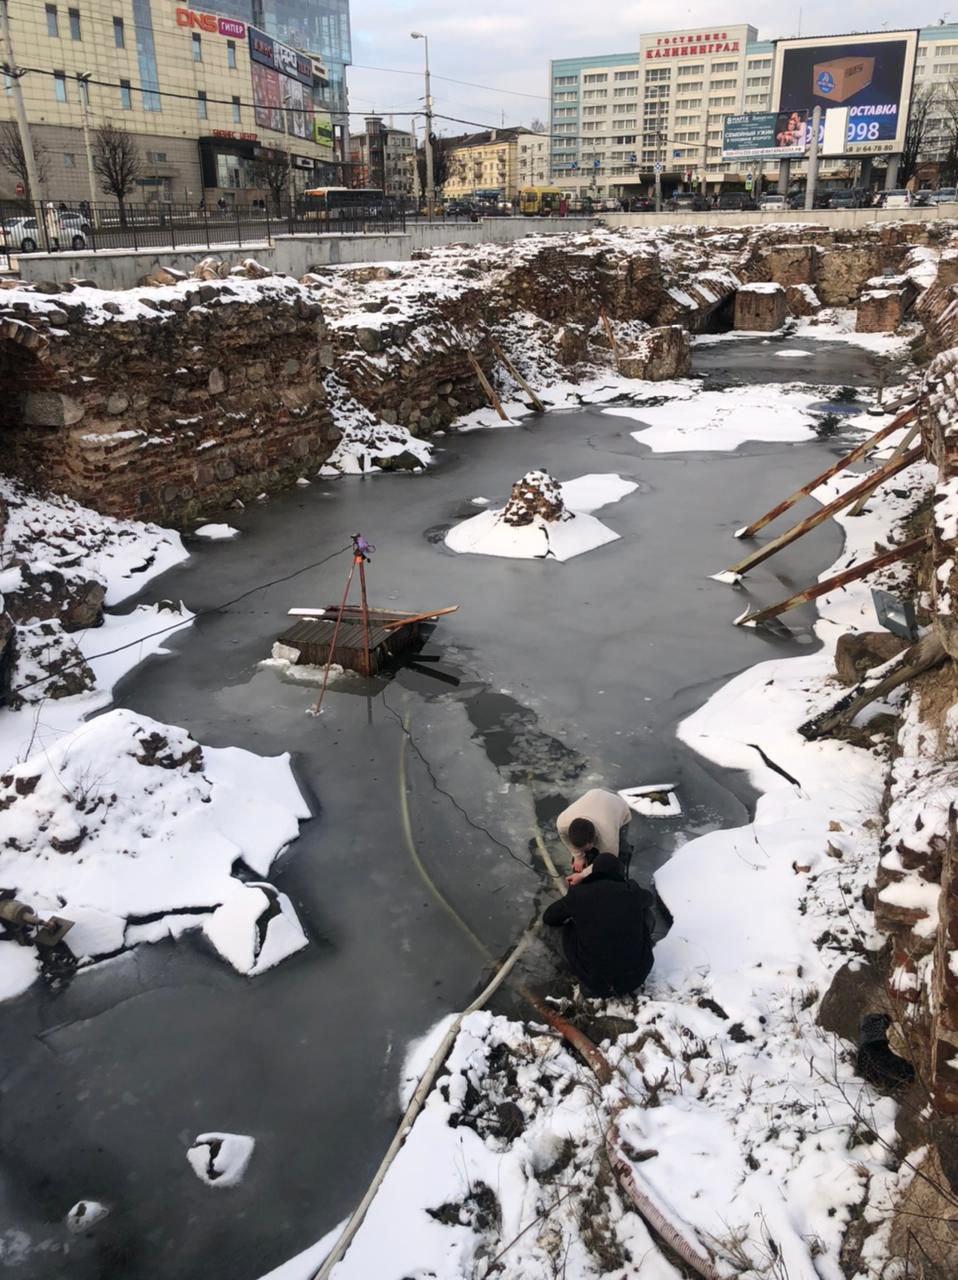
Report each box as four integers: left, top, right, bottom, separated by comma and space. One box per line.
348, 0, 942, 133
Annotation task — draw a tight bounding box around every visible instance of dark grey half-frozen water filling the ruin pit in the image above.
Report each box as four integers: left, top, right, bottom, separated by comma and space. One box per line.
0, 343, 870, 1280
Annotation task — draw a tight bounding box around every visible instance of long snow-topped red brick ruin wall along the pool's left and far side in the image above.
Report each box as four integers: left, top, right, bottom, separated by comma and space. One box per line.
0, 224, 943, 524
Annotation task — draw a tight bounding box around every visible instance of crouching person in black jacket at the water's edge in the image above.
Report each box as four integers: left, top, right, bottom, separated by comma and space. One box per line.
543, 854, 653, 996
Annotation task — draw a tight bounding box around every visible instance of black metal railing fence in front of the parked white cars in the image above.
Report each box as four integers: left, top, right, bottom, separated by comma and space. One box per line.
0, 200, 406, 264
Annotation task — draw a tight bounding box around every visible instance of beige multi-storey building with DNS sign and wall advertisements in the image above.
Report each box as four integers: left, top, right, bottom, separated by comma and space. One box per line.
0, 0, 342, 204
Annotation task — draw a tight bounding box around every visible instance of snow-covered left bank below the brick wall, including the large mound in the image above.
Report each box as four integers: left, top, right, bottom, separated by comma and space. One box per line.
0, 480, 309, 998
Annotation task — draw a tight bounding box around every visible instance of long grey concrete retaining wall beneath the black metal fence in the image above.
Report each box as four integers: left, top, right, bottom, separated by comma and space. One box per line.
17, 218, 593, 289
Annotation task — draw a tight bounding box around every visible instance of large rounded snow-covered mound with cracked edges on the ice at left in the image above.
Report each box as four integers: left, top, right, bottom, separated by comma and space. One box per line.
0, 710, 309, 989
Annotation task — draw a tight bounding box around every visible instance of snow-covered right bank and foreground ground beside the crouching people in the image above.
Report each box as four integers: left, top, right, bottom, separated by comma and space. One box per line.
300, 406, 930, 1280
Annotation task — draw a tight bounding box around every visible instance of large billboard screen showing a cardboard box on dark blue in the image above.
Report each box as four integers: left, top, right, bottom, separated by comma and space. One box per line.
772, 31, 918, 155
